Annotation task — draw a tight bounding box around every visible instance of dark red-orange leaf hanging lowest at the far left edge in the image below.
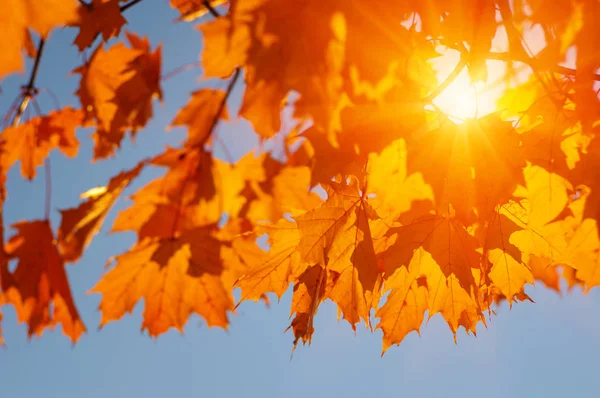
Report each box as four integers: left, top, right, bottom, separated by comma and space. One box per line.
3, 221, 86, 342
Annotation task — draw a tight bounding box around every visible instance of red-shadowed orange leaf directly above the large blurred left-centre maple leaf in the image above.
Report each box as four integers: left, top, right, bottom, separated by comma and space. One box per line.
112, 149, 243, 240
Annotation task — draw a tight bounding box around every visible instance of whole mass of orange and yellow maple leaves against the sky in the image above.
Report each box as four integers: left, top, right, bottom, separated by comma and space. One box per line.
0, 0, 600, 351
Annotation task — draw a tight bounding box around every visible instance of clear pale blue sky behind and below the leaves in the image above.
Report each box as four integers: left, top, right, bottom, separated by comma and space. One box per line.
0, 0, 600, 398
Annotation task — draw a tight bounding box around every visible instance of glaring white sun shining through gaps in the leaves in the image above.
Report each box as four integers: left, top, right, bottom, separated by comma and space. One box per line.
432, 50, 504, 123
